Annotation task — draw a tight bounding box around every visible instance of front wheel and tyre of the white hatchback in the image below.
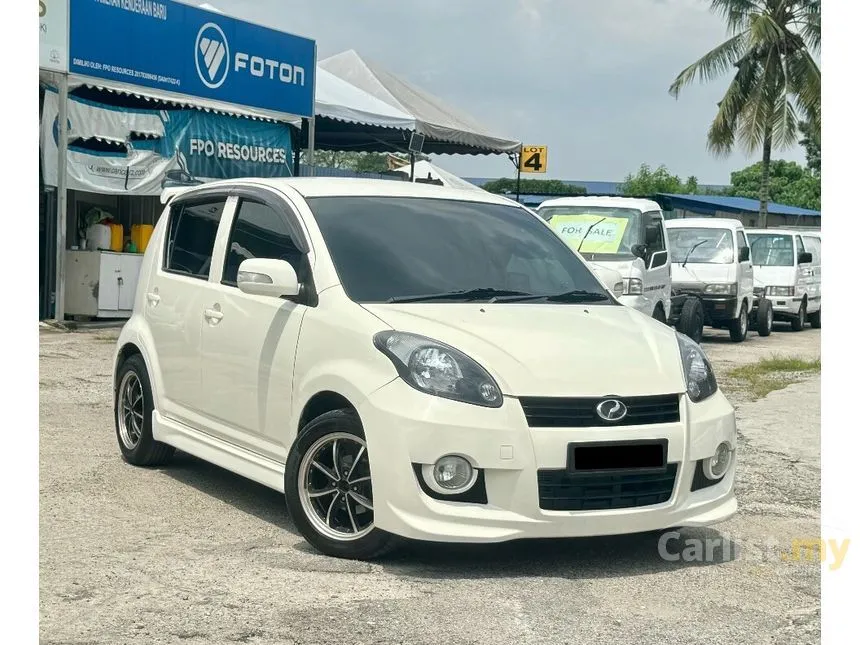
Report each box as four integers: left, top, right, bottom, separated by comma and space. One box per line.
284, 410, 396, 560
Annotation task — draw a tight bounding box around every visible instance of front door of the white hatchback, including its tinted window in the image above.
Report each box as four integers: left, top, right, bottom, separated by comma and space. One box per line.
198, 191, 311, 463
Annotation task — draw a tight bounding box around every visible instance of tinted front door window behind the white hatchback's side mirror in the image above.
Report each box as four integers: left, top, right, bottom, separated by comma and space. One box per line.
221, 199, 303, 285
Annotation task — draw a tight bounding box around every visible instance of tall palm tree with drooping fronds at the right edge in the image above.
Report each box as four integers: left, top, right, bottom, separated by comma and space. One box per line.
669, 0, 821, 227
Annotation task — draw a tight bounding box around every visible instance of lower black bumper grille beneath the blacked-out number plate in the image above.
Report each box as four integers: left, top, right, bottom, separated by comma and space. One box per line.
538, 464, 678, 511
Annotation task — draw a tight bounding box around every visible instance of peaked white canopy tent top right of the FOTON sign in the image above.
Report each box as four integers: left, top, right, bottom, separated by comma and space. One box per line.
319, 50, 521, 154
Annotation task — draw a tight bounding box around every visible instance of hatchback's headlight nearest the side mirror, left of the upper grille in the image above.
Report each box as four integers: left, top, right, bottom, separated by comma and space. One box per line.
373, 331, 502, 408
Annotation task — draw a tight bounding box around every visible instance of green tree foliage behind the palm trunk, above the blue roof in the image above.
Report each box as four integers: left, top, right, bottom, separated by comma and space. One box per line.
729, 159, 821, 210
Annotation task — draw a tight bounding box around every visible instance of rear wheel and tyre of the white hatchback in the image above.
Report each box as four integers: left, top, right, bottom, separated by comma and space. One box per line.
113, 354, 176, 466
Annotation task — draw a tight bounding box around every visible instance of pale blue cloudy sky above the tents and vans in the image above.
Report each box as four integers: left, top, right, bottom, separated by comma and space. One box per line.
186, 0, 803, 183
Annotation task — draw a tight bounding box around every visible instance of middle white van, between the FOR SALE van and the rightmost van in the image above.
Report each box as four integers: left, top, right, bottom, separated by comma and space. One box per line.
666, 217, 773, 342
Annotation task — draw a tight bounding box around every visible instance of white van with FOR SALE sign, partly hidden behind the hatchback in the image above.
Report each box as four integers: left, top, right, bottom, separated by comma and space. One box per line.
537, 197, 672, 322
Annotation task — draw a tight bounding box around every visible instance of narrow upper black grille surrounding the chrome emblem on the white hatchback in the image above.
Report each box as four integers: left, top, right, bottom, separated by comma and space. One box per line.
520, 394, 681, 428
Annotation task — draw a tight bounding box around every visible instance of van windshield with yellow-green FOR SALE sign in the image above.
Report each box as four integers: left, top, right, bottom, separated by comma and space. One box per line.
538, 206, 643, 257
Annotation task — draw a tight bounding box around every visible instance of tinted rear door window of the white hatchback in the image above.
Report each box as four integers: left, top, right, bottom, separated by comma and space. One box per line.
164, 198, 225, 280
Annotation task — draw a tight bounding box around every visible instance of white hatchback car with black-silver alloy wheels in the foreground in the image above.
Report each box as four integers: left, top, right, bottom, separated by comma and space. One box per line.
114, 178, 737, 558
